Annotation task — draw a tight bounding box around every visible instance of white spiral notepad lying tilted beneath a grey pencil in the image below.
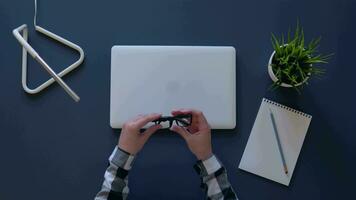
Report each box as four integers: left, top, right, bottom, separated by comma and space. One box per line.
239, 98, 312, 186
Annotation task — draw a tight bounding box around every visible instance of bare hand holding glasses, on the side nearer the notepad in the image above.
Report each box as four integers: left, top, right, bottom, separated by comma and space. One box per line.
171, 109, 213, 160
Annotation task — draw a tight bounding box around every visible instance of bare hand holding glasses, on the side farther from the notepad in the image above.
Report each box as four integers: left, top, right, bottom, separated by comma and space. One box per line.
118, 114, 162, 155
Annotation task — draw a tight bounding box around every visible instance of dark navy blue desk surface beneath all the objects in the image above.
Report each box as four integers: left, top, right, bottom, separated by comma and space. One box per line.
0, 0, 356, 200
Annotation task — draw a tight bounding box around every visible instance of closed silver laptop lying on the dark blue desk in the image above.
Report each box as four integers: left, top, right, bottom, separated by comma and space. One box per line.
110, 46, 236, 129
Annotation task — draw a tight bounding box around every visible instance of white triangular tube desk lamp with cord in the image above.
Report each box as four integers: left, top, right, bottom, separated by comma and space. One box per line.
13, 0, 84, 102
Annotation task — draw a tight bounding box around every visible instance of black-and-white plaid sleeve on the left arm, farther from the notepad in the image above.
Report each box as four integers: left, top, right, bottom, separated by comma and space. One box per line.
95, 146, 135, 200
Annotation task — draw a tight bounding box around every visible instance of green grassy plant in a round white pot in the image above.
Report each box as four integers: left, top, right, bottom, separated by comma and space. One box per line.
268, 23, 331, 91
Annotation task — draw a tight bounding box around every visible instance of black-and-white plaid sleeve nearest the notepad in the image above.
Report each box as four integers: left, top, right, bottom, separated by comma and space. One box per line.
194, 155, 237, 200
